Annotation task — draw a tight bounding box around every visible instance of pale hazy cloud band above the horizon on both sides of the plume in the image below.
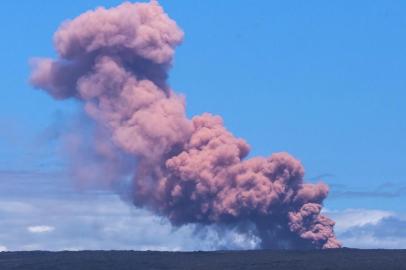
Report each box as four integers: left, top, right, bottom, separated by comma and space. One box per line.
0, 177, 406, 251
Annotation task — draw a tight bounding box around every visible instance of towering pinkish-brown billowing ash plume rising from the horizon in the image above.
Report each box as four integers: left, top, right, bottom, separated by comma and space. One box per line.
31, 1, 340, 248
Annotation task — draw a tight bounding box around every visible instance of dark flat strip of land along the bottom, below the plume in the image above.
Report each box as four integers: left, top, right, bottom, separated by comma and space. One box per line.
0, 249, 406, 270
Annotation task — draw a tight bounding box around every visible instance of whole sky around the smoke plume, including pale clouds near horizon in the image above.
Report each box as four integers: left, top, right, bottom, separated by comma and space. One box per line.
0, 0, 406, 250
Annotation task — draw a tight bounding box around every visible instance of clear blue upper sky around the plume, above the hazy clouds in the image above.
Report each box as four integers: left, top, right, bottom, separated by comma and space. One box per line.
0, 0, 406, 249
